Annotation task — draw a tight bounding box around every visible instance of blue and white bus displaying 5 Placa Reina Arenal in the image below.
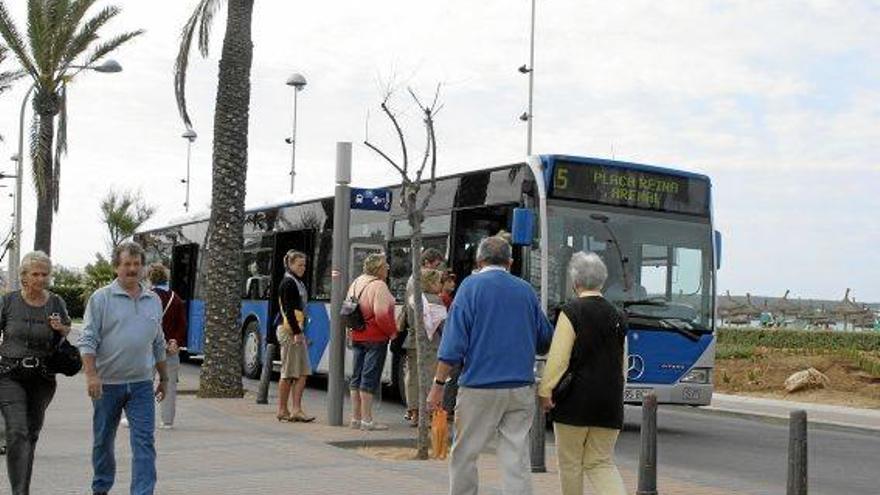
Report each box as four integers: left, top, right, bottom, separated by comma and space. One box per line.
135, 155, 720, 405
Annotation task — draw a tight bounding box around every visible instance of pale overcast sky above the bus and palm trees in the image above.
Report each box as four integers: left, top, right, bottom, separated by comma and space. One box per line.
0, 0, 880, 301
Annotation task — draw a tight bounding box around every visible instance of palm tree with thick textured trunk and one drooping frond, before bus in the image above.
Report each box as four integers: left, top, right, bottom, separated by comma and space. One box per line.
174, 0, 254, 397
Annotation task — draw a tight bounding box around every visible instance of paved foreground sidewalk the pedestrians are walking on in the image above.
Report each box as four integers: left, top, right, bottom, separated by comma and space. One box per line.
13, 366, 737, 495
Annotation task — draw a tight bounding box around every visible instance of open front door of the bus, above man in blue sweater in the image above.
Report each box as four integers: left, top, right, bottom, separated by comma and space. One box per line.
450, 205, 522, 284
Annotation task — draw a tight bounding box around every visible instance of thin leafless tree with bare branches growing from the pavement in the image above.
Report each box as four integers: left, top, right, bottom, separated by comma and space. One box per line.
364, 84, 442, 459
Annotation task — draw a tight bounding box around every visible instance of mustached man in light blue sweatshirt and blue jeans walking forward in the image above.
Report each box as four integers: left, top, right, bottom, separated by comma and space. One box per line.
79, 242, 168, 495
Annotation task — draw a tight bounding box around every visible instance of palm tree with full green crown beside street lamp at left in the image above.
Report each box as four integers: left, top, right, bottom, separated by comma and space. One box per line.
0, 0, 143, 254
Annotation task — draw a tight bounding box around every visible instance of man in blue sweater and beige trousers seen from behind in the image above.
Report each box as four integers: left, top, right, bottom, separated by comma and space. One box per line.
428, 237, 553, 495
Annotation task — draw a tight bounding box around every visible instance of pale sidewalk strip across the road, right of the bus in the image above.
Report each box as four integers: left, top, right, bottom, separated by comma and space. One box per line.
702, 393, 880, 433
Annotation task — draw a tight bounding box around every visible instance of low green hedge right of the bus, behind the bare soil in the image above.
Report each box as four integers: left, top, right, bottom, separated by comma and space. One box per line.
718, 328, 880, 352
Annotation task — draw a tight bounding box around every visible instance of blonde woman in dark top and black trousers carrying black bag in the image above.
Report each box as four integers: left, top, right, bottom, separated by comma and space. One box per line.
0, 251, 70, 495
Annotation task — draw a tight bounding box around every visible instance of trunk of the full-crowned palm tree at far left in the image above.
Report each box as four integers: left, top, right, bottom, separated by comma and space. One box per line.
34, 111, 57, 255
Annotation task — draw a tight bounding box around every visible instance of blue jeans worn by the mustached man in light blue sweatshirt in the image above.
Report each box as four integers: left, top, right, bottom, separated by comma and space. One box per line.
92, 381, 156, 495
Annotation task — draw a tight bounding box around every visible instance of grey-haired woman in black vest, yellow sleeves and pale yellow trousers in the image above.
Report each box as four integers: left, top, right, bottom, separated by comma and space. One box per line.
538, 252, 626, 495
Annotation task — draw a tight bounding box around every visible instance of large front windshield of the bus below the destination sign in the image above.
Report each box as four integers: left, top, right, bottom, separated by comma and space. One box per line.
530, 203, 713, 331
